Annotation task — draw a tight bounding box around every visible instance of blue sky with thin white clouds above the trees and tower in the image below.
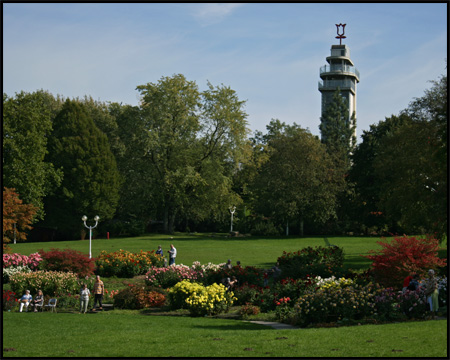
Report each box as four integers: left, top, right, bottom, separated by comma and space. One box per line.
2, 2, 447, 141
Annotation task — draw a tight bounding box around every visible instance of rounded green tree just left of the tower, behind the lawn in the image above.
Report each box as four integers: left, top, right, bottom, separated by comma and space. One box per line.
253, 123, 342, 235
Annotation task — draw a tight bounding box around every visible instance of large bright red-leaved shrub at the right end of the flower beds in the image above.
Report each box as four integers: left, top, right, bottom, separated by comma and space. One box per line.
361, 235, 446, 288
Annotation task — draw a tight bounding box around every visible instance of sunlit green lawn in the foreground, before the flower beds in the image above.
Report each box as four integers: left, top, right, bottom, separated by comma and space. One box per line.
3, 311, 447, 358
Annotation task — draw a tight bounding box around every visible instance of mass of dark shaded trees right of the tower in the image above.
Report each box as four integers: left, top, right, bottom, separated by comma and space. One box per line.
350, 76, 448, 240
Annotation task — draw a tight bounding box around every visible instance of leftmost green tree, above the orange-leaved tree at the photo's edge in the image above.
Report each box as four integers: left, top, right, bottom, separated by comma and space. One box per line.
2, 90, 62, 219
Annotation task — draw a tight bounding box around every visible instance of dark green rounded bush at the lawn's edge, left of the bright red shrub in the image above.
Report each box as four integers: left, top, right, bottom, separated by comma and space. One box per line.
277, 246, 344, 279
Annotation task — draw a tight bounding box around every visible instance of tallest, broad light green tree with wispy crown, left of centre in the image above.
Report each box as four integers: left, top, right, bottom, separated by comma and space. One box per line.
137, 74, 248, 232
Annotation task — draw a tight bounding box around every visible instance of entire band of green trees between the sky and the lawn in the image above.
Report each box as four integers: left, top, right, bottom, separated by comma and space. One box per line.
2, 70, 448, 239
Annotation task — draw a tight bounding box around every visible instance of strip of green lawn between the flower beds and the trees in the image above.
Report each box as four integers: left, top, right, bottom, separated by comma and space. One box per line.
11, 234, 390, 269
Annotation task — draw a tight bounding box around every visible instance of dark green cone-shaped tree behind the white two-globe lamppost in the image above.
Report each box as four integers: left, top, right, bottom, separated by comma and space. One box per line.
41, 100, 119, 239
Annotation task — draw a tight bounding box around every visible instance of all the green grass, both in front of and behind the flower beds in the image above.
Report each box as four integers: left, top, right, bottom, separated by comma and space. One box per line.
3, 234, 447, 358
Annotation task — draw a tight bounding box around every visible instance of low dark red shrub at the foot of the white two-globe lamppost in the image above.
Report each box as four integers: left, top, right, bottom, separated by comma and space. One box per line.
39, 248, 95, 277
